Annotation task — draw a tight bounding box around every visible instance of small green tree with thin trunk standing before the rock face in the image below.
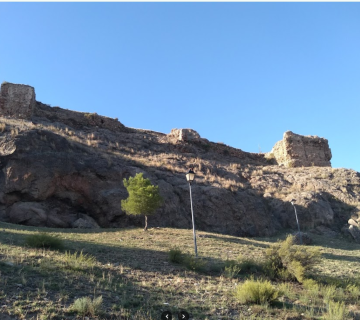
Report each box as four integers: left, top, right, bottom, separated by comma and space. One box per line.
121, 173, 163, 231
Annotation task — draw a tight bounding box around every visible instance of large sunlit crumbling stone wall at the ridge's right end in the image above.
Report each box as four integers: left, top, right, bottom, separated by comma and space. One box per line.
270, 131, 332, 167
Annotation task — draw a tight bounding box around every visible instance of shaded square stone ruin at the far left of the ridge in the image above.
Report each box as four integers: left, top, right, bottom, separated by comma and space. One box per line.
0, 82, 35, 119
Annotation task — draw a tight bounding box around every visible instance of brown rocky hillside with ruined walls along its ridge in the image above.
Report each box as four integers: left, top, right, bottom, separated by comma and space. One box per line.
0, 83, 360, 238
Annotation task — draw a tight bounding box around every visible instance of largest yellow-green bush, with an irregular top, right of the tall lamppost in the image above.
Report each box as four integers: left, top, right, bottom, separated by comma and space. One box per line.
264, 235, 320, 283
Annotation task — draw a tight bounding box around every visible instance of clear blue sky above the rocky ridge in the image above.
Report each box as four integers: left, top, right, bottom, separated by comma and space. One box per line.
0, 2, 360, 171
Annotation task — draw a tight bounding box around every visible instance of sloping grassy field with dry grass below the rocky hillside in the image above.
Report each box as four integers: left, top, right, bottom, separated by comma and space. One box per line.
0, 223, 360, 320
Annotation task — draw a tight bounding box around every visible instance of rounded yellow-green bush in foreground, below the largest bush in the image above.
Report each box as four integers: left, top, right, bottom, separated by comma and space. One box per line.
235, 279, 279, 304
